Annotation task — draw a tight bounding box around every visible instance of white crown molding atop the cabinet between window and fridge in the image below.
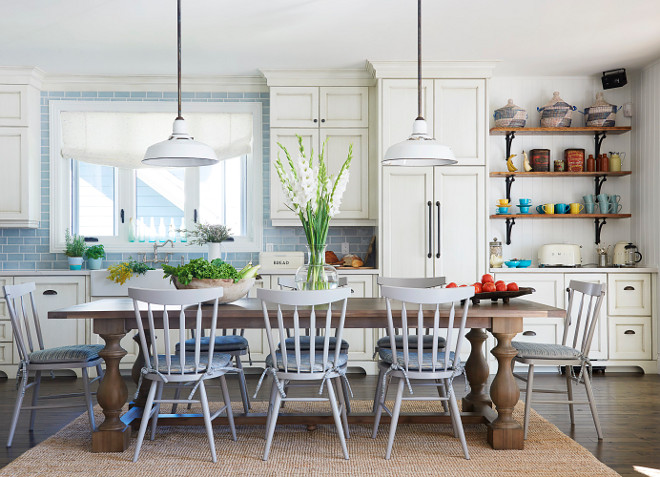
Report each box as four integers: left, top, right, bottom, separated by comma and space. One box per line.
259, 68, 376, 87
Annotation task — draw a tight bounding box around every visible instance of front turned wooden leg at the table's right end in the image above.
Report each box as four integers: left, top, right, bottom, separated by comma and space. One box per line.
488, 330, 523, 449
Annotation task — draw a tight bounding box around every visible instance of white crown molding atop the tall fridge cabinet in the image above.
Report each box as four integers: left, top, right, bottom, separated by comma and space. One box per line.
367, 60, 497, 79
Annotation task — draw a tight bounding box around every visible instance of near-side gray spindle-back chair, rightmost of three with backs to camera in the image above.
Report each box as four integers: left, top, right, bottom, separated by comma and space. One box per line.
372, 286, 474, 459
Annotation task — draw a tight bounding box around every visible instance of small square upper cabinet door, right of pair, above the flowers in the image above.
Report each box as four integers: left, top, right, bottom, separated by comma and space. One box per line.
319, 86, 369, 128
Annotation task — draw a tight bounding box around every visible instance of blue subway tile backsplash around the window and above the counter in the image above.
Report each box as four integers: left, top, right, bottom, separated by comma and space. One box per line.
0, 91, 375, 270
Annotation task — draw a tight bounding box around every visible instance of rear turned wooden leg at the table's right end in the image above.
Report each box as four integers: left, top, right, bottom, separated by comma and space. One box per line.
463, 328, 492, 413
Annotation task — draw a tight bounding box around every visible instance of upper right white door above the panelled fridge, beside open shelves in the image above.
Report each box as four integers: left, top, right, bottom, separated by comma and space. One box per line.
430, 79, 486, 165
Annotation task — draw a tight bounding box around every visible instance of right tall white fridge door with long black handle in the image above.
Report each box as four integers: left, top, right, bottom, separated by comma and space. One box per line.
433, 167, 486, 284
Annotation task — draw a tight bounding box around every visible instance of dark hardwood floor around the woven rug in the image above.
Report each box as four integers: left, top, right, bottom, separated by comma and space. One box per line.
0, 373, 660, 476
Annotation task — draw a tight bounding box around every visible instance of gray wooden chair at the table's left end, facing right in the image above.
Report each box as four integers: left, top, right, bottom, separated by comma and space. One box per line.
3, 282, 103, 447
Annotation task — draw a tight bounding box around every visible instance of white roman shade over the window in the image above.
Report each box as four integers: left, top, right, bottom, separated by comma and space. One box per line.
60, 111, 252, 169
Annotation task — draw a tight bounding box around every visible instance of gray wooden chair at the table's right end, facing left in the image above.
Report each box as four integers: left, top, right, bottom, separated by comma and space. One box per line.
511, 280, 605, 440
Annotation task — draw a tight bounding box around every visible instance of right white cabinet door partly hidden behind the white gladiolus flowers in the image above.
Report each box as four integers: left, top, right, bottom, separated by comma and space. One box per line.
319, 129, 369, 219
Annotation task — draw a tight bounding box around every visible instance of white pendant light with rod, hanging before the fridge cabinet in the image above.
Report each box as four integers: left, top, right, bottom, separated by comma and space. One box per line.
382, 0, 458, 166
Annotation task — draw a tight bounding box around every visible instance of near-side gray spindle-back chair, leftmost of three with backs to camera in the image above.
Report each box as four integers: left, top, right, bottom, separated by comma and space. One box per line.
128, 288, 236, 462
